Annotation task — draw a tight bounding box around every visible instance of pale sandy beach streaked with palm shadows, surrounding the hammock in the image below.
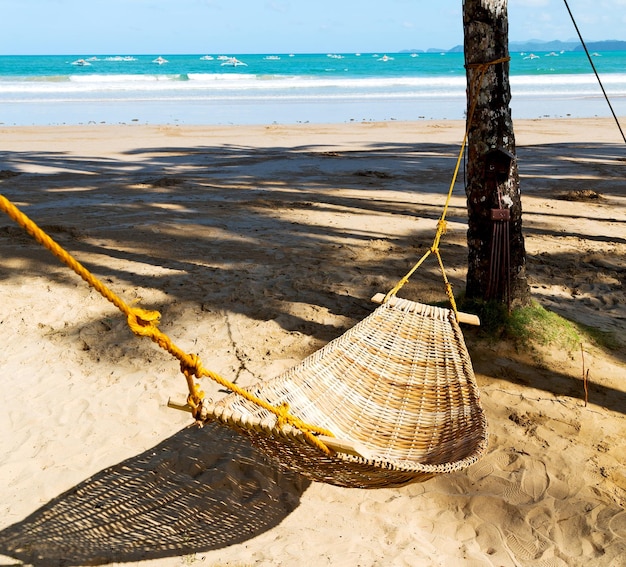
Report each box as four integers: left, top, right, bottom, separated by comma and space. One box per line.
0, 119, 626, 567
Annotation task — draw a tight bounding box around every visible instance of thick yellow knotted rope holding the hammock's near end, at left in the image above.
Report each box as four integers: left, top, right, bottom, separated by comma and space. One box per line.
0, 194, 334, 454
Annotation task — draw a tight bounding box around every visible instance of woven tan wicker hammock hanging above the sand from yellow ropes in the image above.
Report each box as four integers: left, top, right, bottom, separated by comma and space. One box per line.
200, 297, 487, 488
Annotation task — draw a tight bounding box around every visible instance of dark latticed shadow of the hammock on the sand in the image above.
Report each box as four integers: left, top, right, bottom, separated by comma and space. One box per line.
0, 423, 310, 567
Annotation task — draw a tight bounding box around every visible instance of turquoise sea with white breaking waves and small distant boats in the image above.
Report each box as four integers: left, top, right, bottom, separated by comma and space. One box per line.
0, 51, 626, 126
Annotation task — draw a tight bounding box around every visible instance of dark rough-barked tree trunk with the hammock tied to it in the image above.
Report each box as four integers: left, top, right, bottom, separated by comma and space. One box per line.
463, 0, 530, 307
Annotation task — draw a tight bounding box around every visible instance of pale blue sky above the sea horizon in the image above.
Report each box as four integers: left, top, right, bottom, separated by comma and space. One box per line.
0, 0, 626, 55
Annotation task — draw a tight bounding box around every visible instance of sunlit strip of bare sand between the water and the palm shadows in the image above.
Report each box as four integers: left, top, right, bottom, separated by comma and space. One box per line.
0, 118, 623, 148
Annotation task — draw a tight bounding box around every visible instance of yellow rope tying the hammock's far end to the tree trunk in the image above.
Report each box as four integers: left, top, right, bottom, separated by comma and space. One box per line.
383, 57, 510, 314
